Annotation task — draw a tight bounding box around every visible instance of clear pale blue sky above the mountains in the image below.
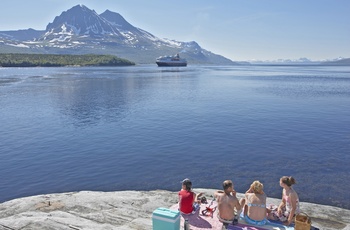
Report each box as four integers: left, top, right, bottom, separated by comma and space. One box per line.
0, 0, 350, 61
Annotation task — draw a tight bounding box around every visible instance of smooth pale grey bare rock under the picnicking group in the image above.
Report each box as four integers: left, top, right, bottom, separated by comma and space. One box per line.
0, 188, 350, 230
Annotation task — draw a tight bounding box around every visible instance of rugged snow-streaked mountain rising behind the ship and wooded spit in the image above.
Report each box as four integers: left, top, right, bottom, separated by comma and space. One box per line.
0, 5, 237, 65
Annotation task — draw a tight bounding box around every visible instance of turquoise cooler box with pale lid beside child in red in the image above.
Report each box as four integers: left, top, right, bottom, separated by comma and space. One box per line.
152, 208, 180, 230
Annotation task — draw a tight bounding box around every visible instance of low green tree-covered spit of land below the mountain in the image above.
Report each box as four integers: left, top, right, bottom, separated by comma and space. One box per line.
0, 53, 135, 67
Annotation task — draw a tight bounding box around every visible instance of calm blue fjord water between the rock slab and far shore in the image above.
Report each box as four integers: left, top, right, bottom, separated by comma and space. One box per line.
0, 65, 350, 209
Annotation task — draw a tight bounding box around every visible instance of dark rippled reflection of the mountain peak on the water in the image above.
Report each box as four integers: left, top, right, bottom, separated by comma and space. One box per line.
54, 78, 133, 126
